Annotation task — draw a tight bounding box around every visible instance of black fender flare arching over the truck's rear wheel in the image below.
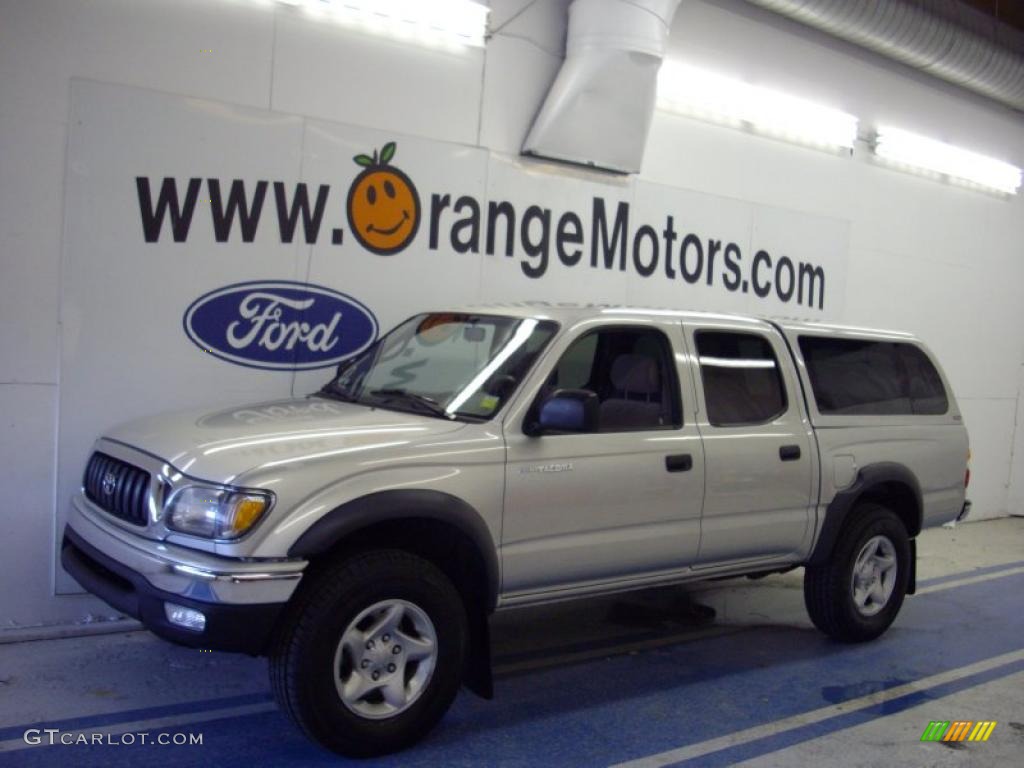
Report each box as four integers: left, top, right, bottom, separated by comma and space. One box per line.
807, 462, 924, 565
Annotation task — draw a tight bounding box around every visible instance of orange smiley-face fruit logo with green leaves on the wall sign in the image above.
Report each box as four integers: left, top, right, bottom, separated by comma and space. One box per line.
346, 141, 420, 256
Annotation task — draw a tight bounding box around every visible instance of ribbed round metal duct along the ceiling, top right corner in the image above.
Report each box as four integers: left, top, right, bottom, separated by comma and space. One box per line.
746, 0, 1024, 112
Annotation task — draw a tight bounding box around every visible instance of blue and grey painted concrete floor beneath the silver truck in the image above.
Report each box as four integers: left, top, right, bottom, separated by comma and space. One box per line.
0, 518, 1024, 768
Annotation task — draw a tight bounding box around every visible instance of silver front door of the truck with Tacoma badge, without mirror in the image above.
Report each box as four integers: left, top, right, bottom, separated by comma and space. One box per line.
502, 321, 703, 597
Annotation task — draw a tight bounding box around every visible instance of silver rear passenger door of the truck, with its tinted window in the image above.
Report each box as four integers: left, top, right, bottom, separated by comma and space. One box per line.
686, 319, 817, 564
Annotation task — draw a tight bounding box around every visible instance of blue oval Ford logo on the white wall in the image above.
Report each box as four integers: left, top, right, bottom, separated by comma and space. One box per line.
182, 281, 377, 371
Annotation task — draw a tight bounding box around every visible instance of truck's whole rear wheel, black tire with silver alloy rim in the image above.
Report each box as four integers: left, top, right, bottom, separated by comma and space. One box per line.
804, 503, 910, 642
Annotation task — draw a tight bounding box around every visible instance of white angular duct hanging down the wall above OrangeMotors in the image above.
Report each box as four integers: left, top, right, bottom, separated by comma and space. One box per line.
522, 0, 679, 173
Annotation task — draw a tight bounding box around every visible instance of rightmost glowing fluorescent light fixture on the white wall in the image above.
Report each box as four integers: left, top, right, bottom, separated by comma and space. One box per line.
874, 126, 1021, 195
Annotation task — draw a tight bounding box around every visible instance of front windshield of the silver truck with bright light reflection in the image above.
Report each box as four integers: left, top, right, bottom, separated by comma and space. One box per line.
319, 313, 557, 421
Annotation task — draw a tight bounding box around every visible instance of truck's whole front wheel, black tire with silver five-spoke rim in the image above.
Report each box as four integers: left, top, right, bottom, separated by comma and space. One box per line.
270, 550, 466, 757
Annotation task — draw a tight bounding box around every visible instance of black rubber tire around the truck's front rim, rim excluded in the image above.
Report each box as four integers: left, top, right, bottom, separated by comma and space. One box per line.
270, 550, 466, 757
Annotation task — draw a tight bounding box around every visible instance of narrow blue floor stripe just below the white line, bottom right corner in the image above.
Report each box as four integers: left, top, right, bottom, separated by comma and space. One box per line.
671, 660, 1024, 768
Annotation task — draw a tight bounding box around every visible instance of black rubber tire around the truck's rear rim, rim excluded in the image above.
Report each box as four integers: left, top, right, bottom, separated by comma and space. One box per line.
804, 502, 910, 643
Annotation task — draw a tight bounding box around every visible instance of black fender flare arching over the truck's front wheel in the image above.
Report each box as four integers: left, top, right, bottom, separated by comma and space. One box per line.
288, 488, 499, 612
